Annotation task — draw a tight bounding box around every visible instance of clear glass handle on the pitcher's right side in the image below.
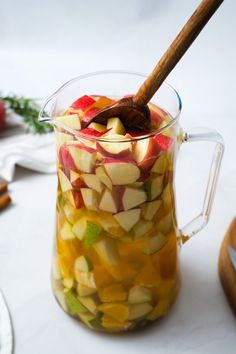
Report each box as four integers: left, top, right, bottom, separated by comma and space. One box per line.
180, 128, 224, 243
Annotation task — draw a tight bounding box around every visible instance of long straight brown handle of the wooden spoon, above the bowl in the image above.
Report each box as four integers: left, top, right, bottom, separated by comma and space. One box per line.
133, 0, 224, 106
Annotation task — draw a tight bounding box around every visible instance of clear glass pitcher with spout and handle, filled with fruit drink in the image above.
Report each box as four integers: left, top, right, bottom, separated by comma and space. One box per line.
39, 71, 224, 332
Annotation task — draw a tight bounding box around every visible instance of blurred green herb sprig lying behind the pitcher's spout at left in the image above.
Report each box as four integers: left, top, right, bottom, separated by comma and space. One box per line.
1, 95, 53, 134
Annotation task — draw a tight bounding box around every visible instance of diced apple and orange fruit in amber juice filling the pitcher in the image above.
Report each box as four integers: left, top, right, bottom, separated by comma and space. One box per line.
53, 96, 179, 332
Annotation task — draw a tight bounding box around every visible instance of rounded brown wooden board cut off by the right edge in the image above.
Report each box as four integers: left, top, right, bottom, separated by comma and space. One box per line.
218, 217, 236, 316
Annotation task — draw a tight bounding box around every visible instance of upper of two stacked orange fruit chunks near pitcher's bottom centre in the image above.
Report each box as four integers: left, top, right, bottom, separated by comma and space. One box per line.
98, 284, 127, 302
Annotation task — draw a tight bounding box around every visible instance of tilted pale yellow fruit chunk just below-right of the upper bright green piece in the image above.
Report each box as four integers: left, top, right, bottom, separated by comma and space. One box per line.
93, 238, 119, 265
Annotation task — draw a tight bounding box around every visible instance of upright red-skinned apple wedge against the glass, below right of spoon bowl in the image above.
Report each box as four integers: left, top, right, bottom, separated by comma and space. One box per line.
134, 138, 160, 170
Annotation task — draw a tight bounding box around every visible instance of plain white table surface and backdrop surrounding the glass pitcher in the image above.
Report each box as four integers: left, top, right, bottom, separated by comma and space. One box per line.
0, 0, 236, 354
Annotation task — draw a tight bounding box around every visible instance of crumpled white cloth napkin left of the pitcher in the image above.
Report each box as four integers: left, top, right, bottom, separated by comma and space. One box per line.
0, 113, 56, 182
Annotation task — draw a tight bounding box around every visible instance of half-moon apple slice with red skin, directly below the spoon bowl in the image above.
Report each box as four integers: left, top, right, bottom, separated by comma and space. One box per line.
96, 134, 132, 158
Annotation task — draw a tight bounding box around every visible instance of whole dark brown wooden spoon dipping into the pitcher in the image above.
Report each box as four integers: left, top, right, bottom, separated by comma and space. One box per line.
84, 0, 223, 131
